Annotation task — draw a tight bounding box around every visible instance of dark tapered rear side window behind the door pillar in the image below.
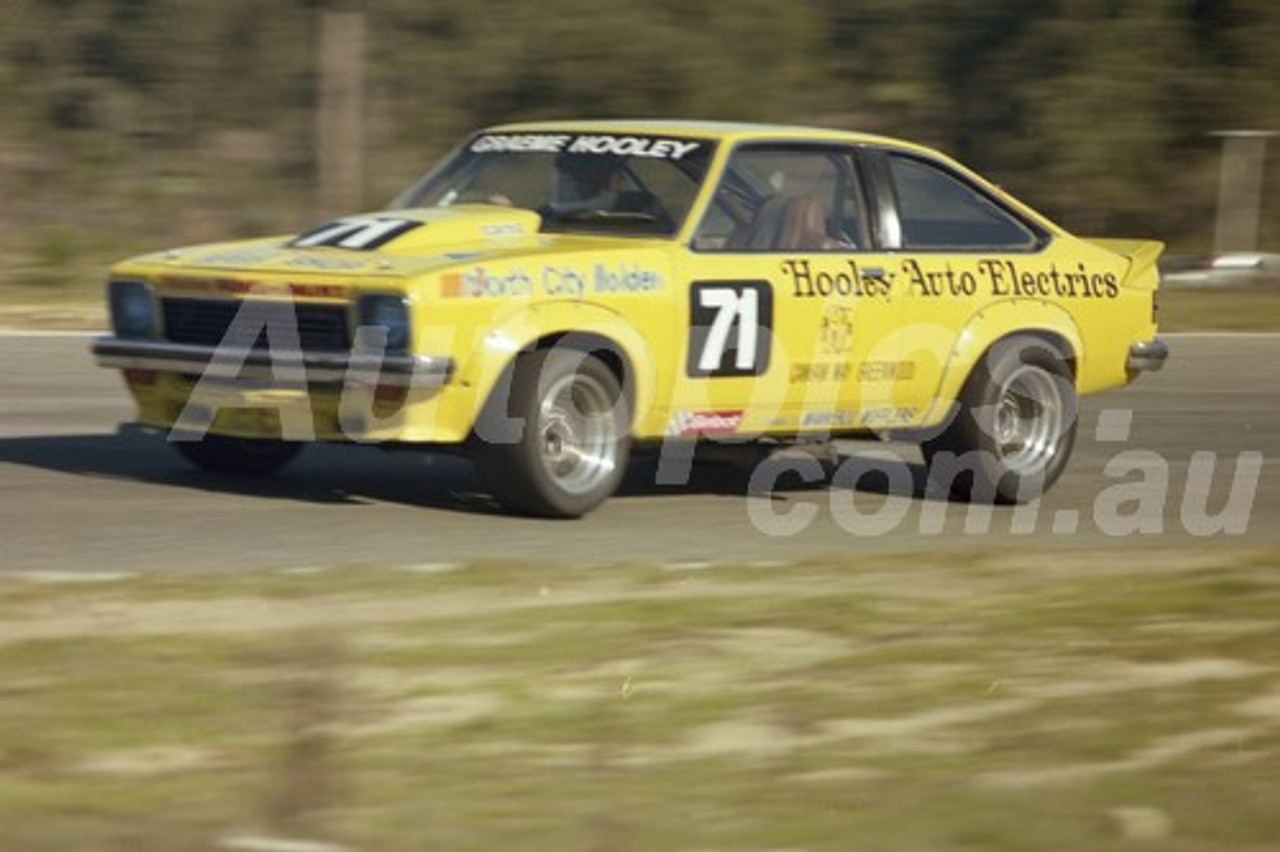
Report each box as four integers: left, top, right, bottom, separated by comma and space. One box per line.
888, 155, 1038, 249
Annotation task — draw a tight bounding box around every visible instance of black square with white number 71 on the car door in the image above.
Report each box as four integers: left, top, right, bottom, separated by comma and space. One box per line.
685, 281, 773, 377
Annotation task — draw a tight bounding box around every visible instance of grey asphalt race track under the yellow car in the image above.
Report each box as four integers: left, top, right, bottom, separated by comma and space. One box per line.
0, 333, 1280, 572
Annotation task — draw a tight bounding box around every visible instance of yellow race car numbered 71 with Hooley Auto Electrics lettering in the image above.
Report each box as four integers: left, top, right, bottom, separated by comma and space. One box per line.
93, 122, 1167, 517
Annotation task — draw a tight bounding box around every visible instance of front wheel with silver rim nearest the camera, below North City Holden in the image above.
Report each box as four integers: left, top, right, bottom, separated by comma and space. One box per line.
472, 349, 631, 518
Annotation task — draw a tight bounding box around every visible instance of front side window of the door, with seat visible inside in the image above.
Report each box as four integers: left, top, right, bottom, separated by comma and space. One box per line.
694, 146, 865, 252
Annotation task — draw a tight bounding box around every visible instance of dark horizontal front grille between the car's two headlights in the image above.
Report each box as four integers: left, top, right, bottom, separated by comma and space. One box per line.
163, 299, 351, 352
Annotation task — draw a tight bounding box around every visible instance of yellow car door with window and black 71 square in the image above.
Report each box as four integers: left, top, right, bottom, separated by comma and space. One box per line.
672, 143, 895, 434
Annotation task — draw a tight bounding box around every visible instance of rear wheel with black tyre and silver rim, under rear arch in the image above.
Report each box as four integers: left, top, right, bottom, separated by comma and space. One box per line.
922, 335, 1076, 504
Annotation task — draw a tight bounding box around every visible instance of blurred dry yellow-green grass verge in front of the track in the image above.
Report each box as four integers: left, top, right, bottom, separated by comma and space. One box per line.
0, 548, 1280, 852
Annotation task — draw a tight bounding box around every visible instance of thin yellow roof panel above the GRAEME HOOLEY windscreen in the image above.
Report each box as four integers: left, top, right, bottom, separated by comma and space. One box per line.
483, 119, 940, 155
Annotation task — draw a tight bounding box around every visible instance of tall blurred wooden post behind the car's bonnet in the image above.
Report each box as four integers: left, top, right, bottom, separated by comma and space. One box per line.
316, 10, 367, 215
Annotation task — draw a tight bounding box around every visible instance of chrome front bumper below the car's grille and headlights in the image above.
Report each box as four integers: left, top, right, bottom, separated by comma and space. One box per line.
92, 336, 454, 388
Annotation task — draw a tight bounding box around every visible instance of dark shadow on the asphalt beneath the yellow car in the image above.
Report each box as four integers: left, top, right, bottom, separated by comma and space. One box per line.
0, 429, 928, 514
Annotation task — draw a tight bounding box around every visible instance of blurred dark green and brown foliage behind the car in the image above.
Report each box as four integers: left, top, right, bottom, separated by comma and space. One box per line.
0, 0, 1280, 290
